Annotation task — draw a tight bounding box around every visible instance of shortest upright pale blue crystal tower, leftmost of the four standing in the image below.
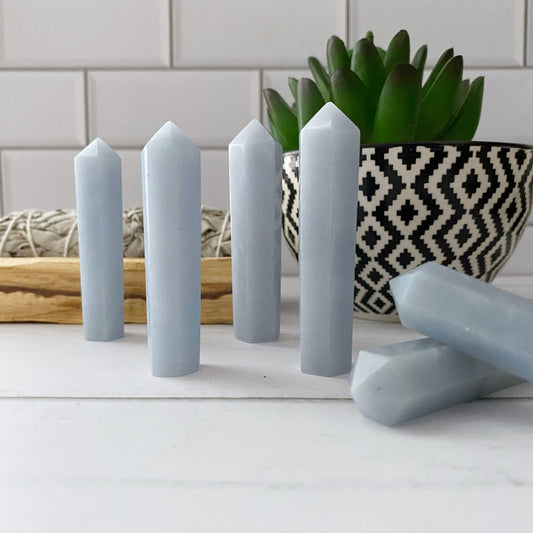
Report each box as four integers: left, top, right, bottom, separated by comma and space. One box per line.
74, 139, 124, 341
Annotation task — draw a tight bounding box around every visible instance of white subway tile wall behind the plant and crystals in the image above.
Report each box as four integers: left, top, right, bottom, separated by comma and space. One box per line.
0, 0, 533, 274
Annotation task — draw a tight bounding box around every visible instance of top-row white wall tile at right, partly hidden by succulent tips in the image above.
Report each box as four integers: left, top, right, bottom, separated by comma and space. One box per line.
350, 0, 524, 66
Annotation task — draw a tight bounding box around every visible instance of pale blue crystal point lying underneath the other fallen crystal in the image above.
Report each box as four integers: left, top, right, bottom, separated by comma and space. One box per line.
350, 338, 523, 426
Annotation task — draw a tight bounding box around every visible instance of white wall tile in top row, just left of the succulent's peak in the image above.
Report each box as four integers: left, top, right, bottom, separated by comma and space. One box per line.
172, 0, 346, 67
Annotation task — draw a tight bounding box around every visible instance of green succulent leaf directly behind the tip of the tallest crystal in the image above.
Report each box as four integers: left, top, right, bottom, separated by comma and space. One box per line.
331, 68, 374, 143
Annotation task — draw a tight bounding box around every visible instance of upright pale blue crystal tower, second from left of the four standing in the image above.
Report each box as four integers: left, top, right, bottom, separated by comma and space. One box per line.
141, 122, 201, 377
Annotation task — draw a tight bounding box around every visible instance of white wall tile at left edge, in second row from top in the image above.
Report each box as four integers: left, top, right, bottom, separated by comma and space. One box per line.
0, 72, 85, 146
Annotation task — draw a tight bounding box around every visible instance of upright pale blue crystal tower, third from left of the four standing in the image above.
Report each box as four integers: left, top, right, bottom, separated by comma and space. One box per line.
229, 120, 281, 342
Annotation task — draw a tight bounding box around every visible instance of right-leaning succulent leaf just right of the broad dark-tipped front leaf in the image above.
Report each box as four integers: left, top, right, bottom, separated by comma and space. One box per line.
416, 56, 463, 141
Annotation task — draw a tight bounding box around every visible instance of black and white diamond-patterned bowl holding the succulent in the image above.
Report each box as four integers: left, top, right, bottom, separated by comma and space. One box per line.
282, 142, 533, 320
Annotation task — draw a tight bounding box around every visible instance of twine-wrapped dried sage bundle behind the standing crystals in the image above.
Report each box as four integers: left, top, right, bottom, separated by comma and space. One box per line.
0, 206, 231, 257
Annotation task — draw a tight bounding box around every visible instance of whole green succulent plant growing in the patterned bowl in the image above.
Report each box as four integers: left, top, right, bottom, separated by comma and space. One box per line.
263, 30, 484, 151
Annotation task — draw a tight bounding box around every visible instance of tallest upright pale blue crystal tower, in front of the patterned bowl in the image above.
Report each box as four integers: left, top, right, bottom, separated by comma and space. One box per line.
299, 102, 360, 376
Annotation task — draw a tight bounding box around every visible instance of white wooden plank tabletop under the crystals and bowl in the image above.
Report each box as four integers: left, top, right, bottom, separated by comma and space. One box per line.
0, 277, 533, 533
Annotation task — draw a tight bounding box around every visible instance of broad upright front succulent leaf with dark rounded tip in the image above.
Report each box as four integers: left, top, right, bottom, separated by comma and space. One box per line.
372, 63, 422, 143
